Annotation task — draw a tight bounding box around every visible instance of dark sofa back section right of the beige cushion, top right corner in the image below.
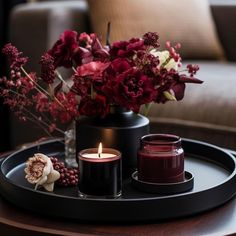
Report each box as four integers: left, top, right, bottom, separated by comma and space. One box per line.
210, 0, 236, 61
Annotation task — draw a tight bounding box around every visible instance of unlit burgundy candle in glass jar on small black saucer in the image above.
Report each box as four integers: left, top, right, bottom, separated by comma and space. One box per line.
138, 134, 184, 183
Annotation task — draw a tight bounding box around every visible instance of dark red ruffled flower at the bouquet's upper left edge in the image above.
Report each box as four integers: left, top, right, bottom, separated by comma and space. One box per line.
48, 30, 78, 68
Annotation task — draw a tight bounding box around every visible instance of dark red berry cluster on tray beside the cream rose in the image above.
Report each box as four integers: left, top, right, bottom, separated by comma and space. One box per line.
50, 157, 79, 187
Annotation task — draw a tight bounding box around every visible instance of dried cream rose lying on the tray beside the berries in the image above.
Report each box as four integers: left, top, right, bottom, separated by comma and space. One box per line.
25, 153, 60, 192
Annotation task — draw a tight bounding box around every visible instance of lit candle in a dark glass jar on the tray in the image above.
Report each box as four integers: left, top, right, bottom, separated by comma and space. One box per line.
78, 148, 122, 198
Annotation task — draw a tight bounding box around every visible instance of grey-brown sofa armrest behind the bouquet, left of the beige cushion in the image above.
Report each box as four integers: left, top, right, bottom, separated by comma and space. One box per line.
9, 0, 89, 72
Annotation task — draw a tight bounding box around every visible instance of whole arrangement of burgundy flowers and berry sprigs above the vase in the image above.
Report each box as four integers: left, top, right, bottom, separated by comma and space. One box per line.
0, 30, 202, 135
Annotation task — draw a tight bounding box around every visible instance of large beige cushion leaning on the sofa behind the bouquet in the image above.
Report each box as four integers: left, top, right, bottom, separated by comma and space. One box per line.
88, 0, 223, 59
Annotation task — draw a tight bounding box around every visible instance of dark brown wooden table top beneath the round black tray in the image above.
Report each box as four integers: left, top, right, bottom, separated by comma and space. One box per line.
0, 150, 236, 236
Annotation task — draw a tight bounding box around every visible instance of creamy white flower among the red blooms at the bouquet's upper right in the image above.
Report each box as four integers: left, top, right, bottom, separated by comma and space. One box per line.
150, 49, 180, 71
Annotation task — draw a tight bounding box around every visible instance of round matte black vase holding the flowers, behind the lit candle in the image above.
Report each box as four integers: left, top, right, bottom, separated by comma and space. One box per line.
76, 107, 149, 177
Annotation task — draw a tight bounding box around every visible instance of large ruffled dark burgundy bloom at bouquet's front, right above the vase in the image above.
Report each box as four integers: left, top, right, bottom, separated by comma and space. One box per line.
110, 68, 156, 112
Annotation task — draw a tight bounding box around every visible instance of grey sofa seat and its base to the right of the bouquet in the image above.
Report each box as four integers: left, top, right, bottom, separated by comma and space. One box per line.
149, 61, 236, 148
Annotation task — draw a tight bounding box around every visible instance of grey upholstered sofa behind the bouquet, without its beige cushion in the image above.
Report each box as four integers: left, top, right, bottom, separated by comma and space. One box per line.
5, 0, 236, 149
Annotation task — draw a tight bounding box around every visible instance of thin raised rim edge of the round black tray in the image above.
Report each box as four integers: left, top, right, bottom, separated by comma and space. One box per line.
0, 139, 236, 221
